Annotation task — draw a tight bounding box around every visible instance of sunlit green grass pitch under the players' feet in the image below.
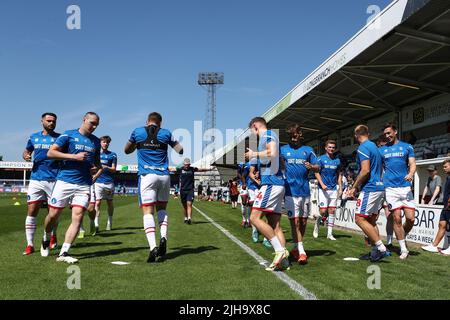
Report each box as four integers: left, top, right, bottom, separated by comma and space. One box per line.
0, 195, 450, 300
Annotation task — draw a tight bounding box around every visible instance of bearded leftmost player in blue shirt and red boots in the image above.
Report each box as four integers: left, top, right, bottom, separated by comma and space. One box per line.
22, 112, 60, 255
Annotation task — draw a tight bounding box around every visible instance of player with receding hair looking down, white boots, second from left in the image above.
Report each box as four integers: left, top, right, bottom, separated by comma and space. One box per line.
41, 112, 101, 263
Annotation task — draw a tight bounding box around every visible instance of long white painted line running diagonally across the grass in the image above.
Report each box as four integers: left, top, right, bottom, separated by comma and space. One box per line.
193, 206, 318, 300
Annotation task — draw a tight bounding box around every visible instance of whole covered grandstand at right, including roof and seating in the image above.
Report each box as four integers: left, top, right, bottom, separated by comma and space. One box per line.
207, 0, 450, 248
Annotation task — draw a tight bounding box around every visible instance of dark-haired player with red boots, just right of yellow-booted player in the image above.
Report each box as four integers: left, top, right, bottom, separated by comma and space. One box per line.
280, 124, 319, 264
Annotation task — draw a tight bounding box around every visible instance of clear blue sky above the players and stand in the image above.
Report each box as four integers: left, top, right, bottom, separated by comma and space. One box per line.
0, 0, 391, 164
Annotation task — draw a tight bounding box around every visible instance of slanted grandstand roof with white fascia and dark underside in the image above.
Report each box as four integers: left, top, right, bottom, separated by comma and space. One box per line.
209, 0, 450, 167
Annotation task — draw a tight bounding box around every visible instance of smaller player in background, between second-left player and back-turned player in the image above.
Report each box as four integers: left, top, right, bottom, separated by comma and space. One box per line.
94, 136, 117, 232
